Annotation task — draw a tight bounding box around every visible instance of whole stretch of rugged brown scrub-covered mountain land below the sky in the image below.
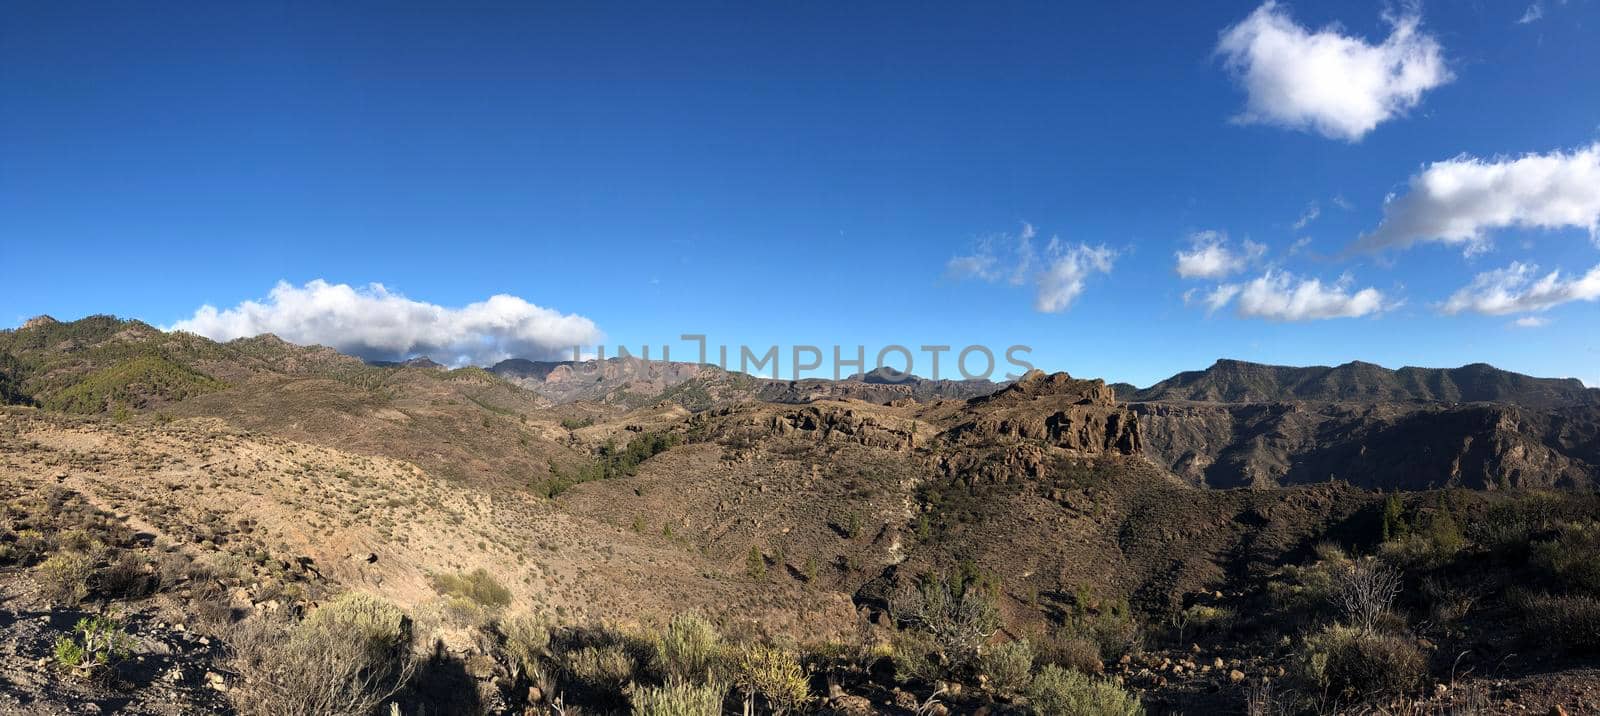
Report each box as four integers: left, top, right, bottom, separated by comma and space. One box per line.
0, 316, 1600, 714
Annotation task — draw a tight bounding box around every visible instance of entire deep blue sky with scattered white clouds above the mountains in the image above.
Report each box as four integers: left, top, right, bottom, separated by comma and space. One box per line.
0, 0, 1600, 385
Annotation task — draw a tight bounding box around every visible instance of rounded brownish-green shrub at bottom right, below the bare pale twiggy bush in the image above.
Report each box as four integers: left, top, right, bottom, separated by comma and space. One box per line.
1302, 625, 1427, 702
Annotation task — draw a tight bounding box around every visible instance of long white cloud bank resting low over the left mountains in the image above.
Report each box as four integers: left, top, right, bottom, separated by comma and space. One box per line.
171, 278, 602, 364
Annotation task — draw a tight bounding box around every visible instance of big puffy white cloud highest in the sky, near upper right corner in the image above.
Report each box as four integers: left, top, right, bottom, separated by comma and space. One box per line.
1216, 0, 1451, 142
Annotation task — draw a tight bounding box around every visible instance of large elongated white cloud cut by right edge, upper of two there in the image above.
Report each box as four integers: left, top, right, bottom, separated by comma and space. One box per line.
1355, 142, 1600, 253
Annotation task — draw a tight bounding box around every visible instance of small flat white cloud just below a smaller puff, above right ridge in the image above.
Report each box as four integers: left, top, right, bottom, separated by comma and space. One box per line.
1206, 270, 1392, 321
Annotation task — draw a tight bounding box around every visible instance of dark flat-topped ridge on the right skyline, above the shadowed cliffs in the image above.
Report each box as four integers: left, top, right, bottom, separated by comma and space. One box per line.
1117, 360, 1600, 408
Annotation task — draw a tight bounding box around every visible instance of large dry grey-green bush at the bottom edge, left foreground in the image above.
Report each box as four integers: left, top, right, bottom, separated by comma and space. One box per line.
230, 595, 414, 716
